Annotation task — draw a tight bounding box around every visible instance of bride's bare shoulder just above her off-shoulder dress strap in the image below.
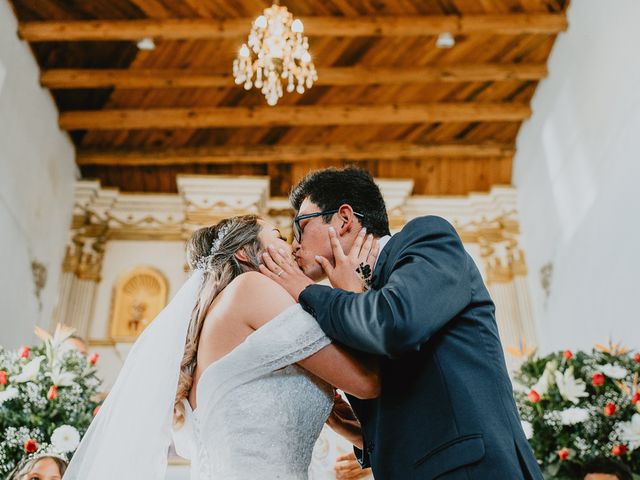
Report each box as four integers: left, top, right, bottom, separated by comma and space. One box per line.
225, 272, 295, 328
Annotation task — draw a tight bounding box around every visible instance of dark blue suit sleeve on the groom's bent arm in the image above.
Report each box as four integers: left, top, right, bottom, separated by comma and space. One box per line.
300, 217, 471, 357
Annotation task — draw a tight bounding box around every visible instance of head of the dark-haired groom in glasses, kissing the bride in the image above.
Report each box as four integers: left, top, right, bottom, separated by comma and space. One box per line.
289, 167, 389, 280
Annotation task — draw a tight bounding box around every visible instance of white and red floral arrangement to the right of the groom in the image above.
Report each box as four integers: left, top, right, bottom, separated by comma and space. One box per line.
514, 343, 640, 478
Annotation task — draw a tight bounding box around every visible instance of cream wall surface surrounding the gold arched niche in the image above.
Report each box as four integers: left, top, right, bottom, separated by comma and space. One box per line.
89, 240, 187, 339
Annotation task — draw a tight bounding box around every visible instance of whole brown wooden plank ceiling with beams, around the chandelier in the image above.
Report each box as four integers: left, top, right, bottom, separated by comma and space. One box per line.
11, 0, 568, 195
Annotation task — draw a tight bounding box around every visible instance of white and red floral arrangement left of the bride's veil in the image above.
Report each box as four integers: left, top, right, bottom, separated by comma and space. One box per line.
0, 325, 101, 478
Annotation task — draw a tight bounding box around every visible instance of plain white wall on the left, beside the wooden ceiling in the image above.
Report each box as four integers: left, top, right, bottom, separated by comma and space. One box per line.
0, 2, 76, 347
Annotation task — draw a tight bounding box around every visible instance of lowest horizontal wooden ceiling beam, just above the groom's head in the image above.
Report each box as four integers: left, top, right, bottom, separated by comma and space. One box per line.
76, 142, 514, 167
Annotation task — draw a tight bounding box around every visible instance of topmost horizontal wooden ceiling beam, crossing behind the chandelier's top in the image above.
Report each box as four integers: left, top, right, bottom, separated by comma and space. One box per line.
18, 13, 567, 42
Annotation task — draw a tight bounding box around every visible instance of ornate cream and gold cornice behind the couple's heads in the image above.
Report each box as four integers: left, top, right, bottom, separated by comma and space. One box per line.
69, 175, 527, 283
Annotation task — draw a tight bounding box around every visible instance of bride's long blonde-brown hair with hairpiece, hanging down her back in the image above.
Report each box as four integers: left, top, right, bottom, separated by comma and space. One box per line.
173, 215, 262, 427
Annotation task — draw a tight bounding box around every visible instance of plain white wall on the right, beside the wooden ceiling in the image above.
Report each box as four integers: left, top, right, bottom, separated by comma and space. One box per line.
513, 0, 640, 351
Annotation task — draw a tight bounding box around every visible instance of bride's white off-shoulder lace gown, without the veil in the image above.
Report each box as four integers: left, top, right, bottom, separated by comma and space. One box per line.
174, 305, 333, 480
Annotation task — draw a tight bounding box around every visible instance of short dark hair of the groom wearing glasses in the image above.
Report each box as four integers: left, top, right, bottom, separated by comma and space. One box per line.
289, 167, 390, 237
